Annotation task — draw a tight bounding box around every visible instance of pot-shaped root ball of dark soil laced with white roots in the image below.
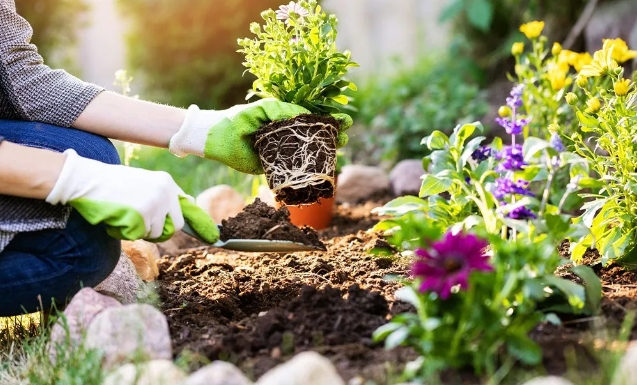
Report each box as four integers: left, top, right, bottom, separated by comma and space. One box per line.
255, 114, 339, 205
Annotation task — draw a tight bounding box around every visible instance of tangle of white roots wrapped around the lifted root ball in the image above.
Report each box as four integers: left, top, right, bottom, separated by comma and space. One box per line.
255, 122, 338, 200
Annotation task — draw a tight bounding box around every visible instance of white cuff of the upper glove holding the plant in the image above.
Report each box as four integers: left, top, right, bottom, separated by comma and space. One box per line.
168, 104, 223, 157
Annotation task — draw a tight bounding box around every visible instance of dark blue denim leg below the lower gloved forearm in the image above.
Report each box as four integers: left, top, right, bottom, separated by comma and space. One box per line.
0, 211, 121, 317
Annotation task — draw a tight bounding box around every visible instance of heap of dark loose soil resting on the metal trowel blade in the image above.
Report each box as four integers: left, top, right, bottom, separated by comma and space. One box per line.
219, 198, 327, 250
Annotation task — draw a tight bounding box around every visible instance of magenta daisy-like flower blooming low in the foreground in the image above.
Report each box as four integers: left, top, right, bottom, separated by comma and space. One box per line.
412, 232, 493, 300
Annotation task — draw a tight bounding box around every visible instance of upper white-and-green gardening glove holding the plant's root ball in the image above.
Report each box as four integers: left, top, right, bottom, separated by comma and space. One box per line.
168, 98, 352, 174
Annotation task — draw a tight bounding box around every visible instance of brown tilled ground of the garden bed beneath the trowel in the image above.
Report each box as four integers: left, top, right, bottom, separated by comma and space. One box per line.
158, 200, 637, 384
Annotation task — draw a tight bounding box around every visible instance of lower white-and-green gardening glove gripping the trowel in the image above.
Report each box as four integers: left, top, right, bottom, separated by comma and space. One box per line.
46, 150, 219, 243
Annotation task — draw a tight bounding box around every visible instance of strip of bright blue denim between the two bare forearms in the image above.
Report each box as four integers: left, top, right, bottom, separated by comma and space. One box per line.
0, 119, 121, 164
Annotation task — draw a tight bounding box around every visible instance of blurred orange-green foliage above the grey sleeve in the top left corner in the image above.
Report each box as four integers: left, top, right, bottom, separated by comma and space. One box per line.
15, 0, 90, 76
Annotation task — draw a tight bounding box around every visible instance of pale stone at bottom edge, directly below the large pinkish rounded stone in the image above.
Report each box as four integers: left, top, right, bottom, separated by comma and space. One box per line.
102, 360, 186, 385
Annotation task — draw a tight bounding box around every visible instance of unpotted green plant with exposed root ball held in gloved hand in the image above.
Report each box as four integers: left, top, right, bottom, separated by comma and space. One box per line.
238, 0, 358, 205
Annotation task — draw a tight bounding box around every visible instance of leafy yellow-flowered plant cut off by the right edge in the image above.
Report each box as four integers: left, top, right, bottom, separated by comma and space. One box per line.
564, 39, 637, 268
